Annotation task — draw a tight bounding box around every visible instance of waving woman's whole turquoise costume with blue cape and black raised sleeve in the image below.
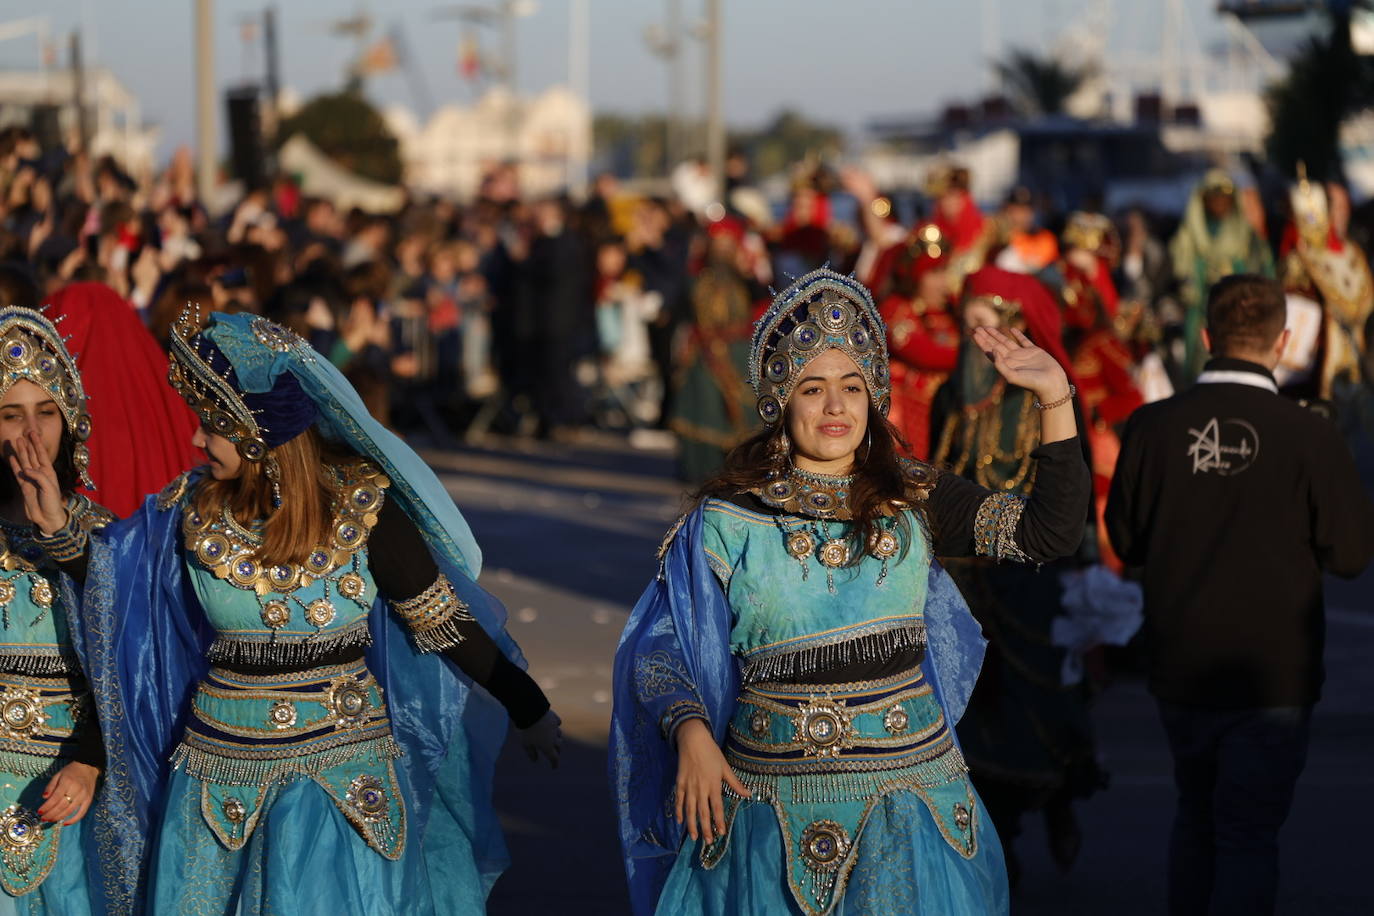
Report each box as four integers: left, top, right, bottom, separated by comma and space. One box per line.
611, 439, 1091, 916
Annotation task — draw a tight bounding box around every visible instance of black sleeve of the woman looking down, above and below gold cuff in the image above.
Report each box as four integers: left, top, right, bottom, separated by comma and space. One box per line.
367, 500, 548, 728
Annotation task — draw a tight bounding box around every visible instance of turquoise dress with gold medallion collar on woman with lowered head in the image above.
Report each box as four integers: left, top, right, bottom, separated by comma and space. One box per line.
150, 461, 485, 916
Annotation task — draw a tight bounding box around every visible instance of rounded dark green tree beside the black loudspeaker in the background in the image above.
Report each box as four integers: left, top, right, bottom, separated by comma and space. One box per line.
273, 89, 401, 184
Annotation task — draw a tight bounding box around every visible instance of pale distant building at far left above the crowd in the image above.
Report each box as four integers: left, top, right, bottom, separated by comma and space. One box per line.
0, 67, 162, 179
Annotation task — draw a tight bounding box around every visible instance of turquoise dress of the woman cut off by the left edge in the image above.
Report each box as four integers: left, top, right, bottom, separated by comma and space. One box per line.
0, 496, 113, 916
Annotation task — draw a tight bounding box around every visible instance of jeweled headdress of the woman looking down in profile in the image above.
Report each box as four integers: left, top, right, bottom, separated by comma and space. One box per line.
168, 305, 317, 461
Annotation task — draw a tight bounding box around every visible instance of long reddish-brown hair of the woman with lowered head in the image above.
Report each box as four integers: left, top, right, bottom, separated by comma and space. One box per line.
192, 426, 353, 566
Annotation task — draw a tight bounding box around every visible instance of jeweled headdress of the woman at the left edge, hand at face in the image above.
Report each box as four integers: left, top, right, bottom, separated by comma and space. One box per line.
0, 306, 95, 489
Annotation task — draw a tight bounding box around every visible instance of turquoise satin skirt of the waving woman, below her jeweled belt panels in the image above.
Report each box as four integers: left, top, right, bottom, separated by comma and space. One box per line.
657, 791, 1010, 916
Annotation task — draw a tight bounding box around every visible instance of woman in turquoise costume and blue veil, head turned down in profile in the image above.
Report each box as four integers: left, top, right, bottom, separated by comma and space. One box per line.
32, 310, 561, 916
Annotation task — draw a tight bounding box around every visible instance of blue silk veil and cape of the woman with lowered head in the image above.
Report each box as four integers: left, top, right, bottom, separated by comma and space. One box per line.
70, 313, 523, 913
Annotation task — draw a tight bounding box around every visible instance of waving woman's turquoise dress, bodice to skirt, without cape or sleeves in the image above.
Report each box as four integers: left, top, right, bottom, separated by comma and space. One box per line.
658, 500, 1007, 913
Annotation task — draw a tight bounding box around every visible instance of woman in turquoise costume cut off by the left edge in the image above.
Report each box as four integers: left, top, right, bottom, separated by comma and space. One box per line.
0, 308, 114, 916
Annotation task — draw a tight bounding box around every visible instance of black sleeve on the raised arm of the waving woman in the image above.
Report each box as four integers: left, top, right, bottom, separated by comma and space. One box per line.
926, 437, 1092, 563
